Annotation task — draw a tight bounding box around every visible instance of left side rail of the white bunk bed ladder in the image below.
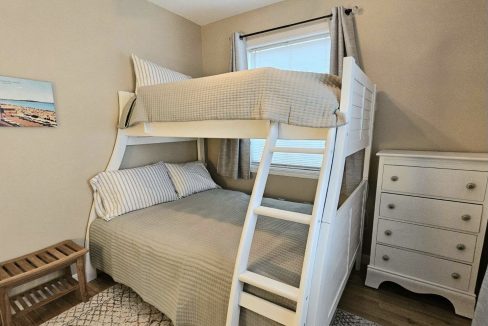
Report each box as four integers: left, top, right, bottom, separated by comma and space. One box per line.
226, 122, 279, 326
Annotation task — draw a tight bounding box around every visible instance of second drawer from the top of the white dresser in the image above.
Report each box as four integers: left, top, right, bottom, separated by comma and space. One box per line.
379, 193, 483, 232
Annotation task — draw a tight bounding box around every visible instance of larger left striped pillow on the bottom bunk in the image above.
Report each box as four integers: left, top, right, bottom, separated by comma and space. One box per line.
90, 162, 178, 221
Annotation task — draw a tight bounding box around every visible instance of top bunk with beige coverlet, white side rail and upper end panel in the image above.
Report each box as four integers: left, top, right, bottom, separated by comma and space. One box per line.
119, 57, 375, 140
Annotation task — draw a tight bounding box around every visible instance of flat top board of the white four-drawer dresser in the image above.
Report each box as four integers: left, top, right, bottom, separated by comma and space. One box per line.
376, 150, 488, 162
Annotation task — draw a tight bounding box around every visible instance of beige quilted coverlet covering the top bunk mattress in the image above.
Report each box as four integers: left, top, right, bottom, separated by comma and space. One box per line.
119, 68, 345, 128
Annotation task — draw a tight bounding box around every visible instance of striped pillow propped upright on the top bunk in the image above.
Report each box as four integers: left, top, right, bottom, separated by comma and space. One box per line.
132, 54, 191, 92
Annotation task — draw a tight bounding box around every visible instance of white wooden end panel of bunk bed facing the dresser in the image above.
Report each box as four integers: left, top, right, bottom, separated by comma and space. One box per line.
306, 58, 376, 325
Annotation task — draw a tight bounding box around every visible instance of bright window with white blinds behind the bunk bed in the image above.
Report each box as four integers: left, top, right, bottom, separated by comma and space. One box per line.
247, 23, 331, 178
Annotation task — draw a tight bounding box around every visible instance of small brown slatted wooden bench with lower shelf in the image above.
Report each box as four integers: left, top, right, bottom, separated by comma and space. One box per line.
0, 240, 88, 326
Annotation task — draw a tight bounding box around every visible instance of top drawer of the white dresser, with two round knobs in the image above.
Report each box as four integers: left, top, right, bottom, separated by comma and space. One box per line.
382, 165, 488, 201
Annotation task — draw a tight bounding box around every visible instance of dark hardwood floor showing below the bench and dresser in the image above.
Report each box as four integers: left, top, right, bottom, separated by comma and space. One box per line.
2, 271, 471, 326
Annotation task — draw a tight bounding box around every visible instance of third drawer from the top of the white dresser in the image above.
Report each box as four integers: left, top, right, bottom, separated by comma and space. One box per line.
376, 218, 476, 263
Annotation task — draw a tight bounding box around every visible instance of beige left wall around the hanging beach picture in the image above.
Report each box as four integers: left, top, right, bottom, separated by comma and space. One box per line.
0, 0, 202, 261
